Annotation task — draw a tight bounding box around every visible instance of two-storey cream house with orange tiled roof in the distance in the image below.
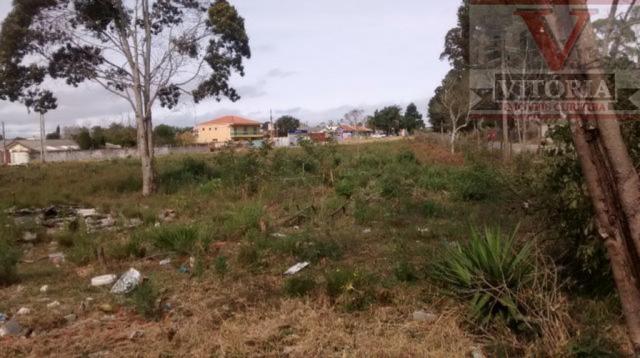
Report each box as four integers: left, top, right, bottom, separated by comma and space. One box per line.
196, 116, 264, 144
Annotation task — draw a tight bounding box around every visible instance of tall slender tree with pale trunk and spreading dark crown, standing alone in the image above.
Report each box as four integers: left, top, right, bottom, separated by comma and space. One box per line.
0, 0, 251, 195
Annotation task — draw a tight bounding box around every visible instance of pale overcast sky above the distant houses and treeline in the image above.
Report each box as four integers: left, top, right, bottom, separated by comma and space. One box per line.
0, 0, 459, 138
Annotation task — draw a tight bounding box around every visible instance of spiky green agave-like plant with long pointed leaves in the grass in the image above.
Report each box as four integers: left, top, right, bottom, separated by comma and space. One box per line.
430, 228, 534, 326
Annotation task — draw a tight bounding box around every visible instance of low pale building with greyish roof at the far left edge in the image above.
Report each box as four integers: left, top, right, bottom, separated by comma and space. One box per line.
5, 139, 80, 165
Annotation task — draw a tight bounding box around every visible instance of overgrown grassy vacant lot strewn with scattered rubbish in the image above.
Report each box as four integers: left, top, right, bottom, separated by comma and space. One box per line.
0, 139, 626, 357
